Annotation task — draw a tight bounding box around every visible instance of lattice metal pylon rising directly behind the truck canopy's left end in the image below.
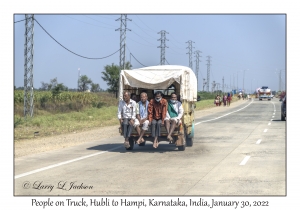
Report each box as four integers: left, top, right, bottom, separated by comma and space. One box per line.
116, 15, 131, 70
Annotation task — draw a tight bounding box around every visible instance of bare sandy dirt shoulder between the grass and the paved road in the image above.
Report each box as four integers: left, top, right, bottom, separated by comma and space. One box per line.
14, 100, 247, 158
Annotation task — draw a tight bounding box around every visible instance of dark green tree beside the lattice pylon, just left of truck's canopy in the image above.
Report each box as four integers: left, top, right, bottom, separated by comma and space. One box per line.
101, 61, 132, 97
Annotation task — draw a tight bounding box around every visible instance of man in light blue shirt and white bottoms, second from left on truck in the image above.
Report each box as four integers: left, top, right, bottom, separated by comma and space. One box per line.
134, 92, 149, 144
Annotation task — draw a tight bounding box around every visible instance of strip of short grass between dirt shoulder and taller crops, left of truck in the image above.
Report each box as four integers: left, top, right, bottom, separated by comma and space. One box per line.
14, 106, 118, 140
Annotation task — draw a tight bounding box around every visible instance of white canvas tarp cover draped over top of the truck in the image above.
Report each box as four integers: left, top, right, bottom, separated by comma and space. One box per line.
119, 65, 197, 101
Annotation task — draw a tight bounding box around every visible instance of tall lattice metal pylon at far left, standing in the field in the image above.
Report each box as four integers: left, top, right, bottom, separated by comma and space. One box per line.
24, 14, 34, 119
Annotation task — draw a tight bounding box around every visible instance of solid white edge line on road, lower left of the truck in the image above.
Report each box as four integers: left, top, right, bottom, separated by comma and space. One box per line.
15, 146, 123, 179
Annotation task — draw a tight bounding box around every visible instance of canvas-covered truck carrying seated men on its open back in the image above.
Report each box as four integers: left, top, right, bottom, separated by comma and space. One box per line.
119, 65, 197, 151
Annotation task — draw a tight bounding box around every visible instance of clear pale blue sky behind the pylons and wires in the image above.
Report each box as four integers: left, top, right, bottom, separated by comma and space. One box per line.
14, 13, 286, 92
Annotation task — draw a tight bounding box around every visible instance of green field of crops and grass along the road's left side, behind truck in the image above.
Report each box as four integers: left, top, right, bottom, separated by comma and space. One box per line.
14, 90, 238, 140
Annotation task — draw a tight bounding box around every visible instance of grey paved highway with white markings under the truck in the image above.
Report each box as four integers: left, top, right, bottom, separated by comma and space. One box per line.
14, 99, 286, 196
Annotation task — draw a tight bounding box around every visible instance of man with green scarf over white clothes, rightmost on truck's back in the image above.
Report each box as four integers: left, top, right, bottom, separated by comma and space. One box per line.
165, 92, 183, 144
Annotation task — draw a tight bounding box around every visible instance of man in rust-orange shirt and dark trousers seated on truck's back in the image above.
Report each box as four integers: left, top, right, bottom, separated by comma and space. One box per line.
148, 91, 168, 148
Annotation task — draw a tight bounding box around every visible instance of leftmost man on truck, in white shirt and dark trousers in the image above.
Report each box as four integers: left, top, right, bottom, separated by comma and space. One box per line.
118, 91, 136, 148
